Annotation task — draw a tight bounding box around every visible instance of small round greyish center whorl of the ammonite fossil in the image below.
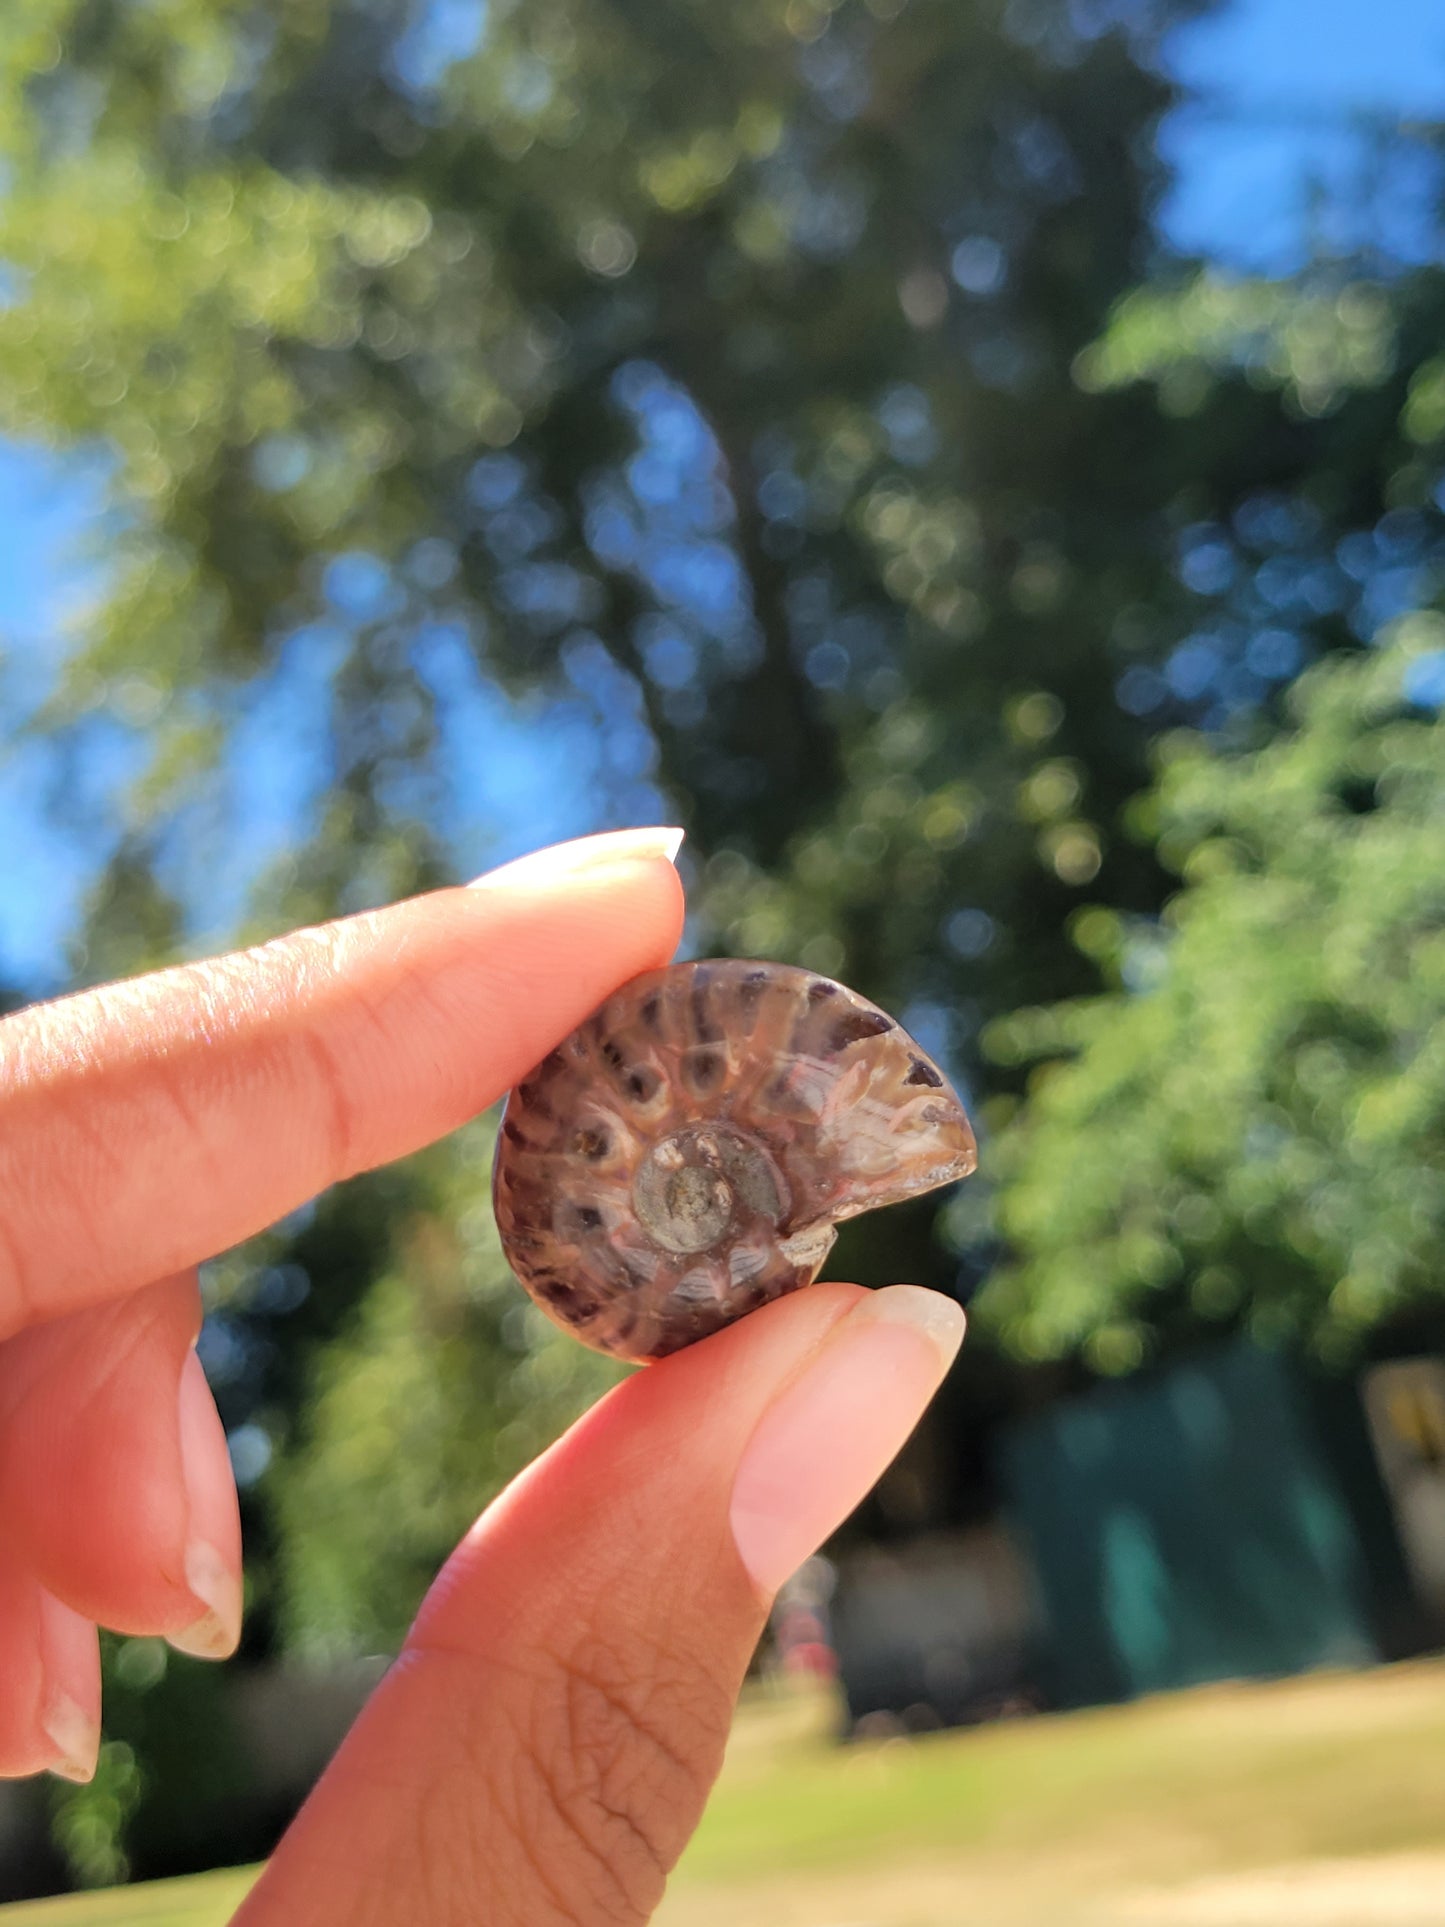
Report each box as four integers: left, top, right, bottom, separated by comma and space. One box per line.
632, 1123, 788, 1251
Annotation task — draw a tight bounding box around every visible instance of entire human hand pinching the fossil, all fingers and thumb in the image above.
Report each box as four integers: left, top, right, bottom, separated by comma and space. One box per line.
0, 831, 963, 1927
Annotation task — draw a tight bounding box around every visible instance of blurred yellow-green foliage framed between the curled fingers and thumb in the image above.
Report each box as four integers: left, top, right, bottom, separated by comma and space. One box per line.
270, 1125, 620, 1657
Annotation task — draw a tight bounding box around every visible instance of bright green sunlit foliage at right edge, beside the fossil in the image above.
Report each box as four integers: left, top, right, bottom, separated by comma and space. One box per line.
983, 615, 1445, 1372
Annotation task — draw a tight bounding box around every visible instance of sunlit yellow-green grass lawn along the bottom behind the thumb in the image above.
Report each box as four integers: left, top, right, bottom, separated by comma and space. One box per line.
0, 1661, 1445, 1927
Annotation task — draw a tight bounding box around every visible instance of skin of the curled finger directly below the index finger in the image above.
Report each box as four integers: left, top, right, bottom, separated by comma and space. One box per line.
0, 1272, 223, 1632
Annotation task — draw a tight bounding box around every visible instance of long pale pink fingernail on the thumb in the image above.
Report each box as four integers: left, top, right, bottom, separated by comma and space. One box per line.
730, 1285, 963, 1594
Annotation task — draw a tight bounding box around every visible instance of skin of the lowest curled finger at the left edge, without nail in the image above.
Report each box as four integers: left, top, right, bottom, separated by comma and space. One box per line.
0, 1547, 100, 1779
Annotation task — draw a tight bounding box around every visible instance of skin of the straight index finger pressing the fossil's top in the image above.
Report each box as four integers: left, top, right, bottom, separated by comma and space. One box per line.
0, 858, 682, 1337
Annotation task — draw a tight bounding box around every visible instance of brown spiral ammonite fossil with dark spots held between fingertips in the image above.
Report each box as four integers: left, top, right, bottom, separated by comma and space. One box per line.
491, 960, 975, 1359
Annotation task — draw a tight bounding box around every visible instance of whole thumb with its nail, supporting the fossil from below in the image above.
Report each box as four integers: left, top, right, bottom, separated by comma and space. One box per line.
237, 1285, 963, 1927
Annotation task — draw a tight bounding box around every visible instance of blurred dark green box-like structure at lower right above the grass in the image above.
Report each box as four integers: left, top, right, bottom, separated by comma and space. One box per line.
1000, 1345, 1422, 1705
